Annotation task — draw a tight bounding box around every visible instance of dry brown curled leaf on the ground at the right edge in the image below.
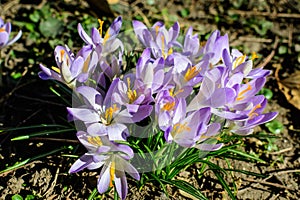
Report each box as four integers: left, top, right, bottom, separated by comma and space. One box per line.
275, 66, 300, 110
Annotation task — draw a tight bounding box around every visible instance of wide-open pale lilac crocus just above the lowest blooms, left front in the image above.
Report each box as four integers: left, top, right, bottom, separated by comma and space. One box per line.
67, 79, 134, 141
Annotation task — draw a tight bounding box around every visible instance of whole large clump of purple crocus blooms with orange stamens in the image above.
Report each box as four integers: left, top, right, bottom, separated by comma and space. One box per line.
39, 17, 277, 199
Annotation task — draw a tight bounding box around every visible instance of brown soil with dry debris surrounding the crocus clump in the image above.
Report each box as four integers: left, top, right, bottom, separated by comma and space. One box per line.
0, 0, 300, 200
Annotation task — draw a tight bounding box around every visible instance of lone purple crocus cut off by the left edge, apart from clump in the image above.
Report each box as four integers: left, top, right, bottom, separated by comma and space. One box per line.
0, 17, 22, 49
